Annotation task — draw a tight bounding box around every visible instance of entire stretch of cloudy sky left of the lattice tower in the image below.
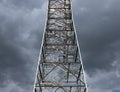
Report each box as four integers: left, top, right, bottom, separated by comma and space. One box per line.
0, 0, 46, 92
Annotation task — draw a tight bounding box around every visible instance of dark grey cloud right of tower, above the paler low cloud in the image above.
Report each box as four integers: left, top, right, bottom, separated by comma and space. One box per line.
71, 0, 120, 73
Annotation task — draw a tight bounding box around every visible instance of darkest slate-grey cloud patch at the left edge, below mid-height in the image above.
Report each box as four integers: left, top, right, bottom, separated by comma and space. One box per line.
0, 32, 29, 85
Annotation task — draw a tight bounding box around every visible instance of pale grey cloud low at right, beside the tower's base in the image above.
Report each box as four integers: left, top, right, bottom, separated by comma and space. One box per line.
88, 70, 120, 92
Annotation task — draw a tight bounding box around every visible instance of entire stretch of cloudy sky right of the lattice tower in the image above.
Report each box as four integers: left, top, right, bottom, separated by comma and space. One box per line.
73, 0, 120, 92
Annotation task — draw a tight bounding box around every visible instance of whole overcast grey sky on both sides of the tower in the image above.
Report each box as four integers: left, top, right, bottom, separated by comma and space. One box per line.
0, 0, 120, 92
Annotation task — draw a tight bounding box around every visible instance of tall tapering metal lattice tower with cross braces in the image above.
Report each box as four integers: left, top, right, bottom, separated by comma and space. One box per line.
33, 0, 87, 92
